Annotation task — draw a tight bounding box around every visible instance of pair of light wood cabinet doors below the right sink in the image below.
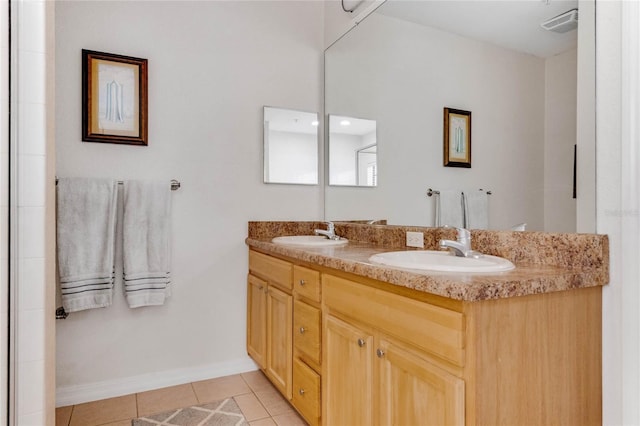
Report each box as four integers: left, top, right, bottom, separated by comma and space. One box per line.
323, 315, 464, 425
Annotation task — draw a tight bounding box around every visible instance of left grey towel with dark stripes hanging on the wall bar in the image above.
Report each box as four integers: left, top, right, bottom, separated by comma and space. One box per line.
57, 178, 118, 312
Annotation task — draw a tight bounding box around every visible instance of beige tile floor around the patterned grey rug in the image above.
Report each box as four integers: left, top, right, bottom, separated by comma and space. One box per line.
56, 371, 306, 426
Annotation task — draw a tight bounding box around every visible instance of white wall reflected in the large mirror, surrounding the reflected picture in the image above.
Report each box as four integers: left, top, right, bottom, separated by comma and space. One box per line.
325, 13, 545, 230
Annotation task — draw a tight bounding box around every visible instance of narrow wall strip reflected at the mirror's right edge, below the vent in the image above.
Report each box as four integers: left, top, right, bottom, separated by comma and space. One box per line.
544, 49, 577, 232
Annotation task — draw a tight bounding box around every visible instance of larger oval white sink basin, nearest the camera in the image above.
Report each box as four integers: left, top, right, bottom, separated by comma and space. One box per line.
369, 250, 515, 272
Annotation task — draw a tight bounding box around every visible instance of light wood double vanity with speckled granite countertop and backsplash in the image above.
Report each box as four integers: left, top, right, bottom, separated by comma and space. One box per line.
246, 222, 608, 425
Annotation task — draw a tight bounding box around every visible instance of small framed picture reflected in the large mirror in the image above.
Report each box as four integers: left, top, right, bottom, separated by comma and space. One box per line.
444, 108, 471, 168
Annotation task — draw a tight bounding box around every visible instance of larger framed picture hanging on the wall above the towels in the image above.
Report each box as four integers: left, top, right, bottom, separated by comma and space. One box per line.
82, 49, 148, 146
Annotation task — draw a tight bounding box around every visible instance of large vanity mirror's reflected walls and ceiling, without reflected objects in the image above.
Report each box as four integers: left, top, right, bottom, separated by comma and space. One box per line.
325, 0, 595, 232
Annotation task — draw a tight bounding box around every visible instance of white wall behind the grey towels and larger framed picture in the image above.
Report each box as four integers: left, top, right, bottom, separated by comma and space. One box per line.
56, 1, 323, 405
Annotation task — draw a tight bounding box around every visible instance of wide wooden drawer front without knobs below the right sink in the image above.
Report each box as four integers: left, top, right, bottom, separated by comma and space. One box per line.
322, 274, 465, 367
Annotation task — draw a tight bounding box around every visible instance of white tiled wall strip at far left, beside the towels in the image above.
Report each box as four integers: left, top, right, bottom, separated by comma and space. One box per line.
9, 0, 54, 425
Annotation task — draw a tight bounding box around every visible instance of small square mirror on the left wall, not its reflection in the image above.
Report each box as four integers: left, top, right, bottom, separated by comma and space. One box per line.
264, 107, 318, 185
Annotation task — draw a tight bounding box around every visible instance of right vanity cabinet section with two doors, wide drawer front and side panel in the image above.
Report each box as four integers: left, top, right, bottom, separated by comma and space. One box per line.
322, 274, 602, 425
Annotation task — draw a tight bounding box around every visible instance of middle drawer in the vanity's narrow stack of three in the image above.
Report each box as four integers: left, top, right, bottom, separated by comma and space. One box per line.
293, 300, 322, 364
